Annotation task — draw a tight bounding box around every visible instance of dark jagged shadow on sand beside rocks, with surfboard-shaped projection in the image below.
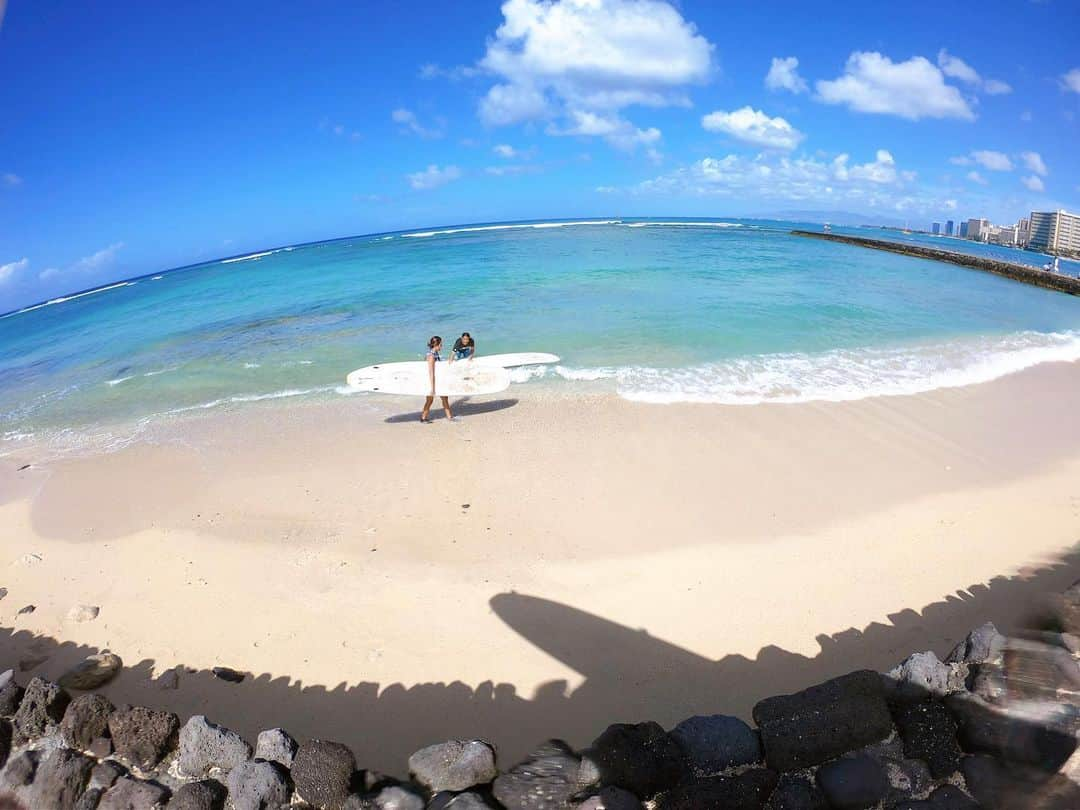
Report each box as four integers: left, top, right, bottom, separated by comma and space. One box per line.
0, 552, 1080, 775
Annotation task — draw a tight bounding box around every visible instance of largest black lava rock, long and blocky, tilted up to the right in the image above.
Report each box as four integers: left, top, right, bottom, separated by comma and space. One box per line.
754, 670, 892, 771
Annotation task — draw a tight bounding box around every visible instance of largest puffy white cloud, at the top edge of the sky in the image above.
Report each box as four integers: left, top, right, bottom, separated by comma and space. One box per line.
480, 0, 713, 146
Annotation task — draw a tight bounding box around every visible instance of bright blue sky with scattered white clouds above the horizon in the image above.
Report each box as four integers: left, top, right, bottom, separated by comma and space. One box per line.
0, 0, 1080, 311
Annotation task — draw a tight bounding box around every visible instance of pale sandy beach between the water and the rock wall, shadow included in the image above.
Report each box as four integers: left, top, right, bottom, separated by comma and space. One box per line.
0, 364, 1080, 774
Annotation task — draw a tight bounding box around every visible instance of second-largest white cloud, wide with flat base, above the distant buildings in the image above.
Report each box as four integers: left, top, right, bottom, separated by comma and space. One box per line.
815, 51, 975, 121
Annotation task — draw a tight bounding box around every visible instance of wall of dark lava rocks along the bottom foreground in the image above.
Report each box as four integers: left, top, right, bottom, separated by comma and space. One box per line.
0, 583, 1080, 810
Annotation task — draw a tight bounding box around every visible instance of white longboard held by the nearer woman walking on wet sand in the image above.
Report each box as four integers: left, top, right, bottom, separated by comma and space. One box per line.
346, 360, 510, 396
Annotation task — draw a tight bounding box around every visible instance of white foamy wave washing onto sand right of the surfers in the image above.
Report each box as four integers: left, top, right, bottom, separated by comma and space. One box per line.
554, 332, 1080, 405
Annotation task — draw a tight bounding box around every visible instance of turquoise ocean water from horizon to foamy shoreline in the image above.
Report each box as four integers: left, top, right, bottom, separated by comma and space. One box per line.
0, 219, 1080, 453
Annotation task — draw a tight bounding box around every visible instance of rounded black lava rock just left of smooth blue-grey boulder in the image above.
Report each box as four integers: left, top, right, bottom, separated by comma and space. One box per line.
582, 723, 688, 799
